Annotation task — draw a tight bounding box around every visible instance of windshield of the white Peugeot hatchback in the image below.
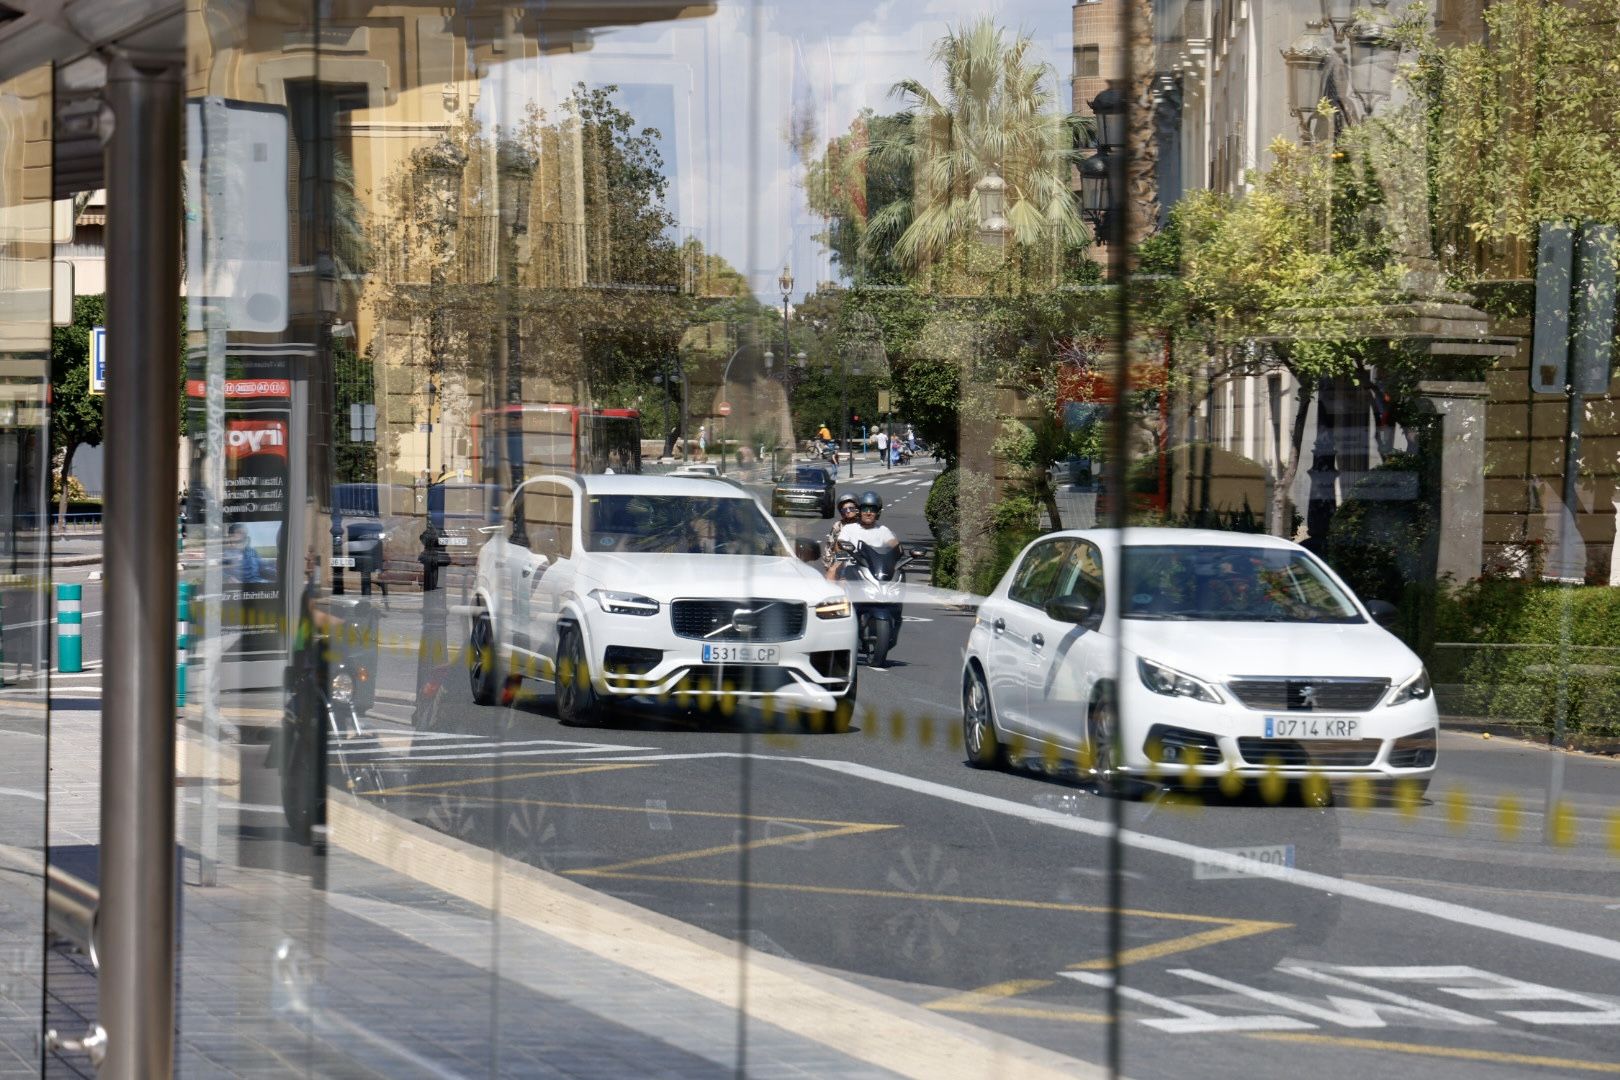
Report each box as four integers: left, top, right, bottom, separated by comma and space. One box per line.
1121, 544, 1364, 623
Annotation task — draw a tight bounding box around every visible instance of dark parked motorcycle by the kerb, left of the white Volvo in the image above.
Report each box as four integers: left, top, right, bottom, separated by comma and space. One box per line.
272, 597, 386, 844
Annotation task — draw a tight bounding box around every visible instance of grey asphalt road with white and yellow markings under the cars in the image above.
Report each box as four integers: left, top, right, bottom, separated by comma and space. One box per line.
332, 463, 1620, 1080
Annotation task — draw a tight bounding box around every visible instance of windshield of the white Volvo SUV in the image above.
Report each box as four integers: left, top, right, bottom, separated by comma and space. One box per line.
585, 495, 789, 555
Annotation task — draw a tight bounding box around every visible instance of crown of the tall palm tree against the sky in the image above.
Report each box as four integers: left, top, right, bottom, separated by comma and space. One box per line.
862, 19, 1085, 272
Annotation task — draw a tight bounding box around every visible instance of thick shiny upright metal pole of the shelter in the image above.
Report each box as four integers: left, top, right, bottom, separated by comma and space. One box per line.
97, 55, 181, 1080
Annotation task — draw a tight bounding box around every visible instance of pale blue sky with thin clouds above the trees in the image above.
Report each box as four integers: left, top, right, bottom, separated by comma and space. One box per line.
481, 0, 1072, 300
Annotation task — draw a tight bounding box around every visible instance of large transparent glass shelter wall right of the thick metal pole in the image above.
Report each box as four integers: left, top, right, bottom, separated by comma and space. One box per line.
177, 0, 1620, 1075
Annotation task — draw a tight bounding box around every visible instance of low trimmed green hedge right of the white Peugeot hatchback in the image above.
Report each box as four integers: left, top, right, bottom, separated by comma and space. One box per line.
1427, 578, 1620, 737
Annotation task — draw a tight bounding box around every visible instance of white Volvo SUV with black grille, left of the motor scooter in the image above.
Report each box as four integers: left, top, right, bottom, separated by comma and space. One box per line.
470, 473, 855, 724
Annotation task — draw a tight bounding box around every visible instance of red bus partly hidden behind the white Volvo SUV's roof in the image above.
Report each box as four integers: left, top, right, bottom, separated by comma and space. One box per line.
473, 403, 642, 492
